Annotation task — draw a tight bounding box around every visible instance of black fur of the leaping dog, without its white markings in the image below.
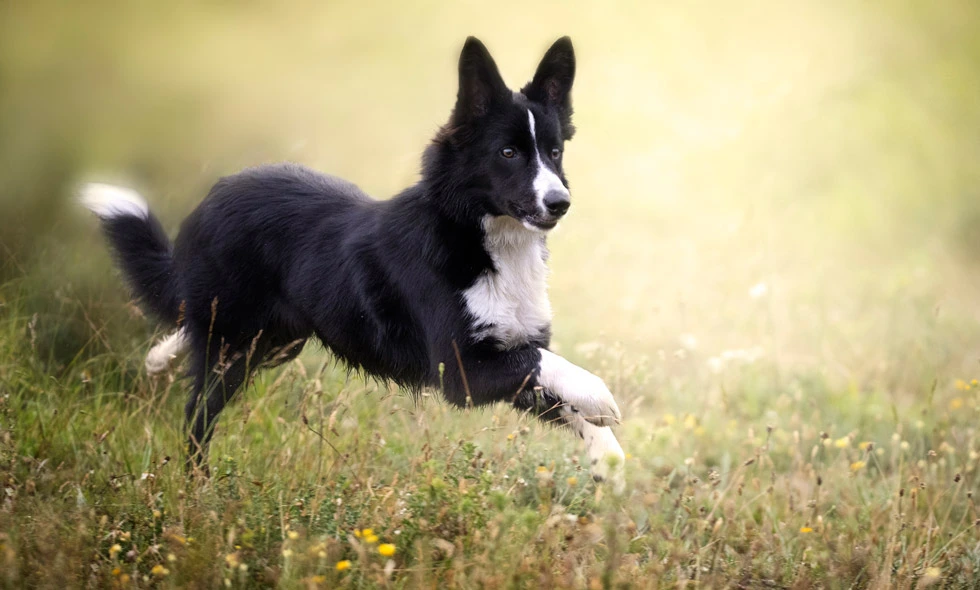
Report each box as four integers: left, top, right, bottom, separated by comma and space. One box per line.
91, 38, 575, 470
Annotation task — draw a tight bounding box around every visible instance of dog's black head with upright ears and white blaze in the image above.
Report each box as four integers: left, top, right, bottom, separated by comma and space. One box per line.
426, 37, 575, 231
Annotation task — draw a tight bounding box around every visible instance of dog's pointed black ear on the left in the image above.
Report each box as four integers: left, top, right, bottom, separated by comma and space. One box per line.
454, 37, 510, 122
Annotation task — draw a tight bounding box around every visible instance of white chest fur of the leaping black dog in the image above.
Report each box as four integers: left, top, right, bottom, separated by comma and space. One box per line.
463, 217, 551, 348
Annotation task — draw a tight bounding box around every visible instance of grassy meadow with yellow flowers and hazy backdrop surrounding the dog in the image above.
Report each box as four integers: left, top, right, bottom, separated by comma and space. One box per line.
0, 0, 980, 589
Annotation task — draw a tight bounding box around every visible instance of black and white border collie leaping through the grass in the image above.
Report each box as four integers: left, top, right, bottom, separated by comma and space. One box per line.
81, 37, 624, 488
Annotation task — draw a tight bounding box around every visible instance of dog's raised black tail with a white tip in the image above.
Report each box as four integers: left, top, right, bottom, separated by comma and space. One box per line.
79, 183, 180, 324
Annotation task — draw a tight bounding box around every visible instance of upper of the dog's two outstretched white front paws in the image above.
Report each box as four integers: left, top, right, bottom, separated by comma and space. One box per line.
538, 348, 622, 428
